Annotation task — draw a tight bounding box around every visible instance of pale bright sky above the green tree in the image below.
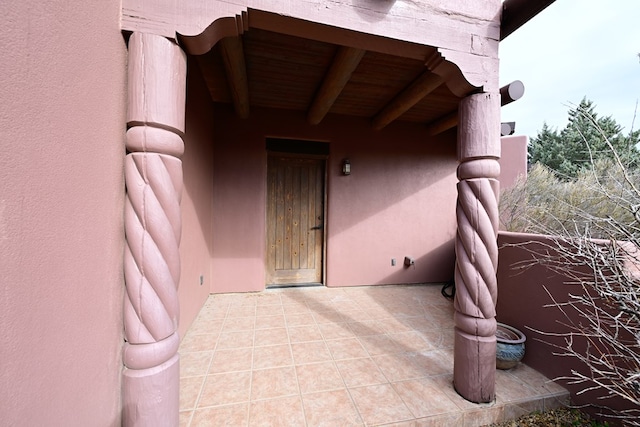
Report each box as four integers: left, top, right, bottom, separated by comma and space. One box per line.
500, 0, 640, 137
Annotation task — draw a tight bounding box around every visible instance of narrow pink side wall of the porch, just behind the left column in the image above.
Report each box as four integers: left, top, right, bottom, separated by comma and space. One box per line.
178, 58, 213, 337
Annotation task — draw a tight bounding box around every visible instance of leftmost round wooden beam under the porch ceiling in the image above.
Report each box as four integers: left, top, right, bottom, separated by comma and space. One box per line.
220, 36, 249, 119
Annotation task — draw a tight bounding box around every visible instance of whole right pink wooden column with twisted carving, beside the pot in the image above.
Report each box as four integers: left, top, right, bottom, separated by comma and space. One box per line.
453, 93, 500, 403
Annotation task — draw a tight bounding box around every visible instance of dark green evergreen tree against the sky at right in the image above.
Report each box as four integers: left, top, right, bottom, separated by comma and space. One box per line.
529, 98, 640, 179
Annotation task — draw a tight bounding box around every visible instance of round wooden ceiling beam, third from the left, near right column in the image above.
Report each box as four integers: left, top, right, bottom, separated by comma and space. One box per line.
372, 71, 444, 130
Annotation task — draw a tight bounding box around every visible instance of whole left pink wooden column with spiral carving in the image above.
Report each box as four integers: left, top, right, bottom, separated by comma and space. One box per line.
123, 33, 186, 426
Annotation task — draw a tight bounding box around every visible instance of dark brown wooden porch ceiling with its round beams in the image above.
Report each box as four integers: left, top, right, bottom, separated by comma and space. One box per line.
198, 28, 460, 133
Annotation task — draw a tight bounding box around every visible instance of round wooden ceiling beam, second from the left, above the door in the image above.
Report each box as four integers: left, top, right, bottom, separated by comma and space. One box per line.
307, 46, 366, 125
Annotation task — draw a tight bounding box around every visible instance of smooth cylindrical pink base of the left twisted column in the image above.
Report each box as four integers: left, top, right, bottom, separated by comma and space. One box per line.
122, 354, 180, 427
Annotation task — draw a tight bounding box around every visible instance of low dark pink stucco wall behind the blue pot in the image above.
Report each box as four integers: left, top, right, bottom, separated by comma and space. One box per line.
497, 232, 629, 422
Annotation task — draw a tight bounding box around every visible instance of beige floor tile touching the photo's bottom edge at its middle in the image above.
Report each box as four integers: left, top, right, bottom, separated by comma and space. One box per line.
302, 390, 362, 427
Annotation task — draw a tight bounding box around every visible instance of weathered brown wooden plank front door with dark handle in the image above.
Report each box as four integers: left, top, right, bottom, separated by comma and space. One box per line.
266, 154, 324, 285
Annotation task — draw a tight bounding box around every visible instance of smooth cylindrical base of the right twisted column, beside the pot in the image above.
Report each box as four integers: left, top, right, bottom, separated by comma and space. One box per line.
453, 328, 496, 403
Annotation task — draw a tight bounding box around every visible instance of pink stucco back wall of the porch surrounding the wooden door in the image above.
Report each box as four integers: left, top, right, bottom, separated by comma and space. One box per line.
211, 107, 457, 292
